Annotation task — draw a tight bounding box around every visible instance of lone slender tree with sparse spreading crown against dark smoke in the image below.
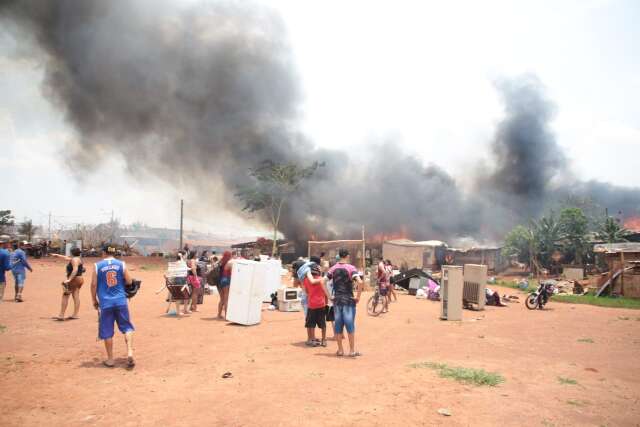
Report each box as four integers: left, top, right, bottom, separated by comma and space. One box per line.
235, 160, 324, 256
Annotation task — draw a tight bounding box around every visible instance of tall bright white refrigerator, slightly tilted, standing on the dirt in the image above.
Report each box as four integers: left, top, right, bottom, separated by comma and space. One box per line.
227, 260, 267, 325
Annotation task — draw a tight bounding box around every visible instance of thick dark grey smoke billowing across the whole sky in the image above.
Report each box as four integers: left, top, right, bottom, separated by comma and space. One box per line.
0, 0, 640, 247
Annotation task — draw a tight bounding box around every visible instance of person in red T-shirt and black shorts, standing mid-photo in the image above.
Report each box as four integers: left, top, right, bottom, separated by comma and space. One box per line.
303, 263, 331, 347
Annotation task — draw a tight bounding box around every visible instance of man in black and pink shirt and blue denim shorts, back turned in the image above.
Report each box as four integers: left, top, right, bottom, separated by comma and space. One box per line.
327, 249, 362, 357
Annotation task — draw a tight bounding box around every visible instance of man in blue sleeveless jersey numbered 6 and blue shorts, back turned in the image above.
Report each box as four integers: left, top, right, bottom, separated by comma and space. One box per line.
91, 247, 135, 369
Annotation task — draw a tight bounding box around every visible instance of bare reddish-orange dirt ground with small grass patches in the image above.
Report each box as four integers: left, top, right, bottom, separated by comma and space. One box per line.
0, 258, 640, 426
